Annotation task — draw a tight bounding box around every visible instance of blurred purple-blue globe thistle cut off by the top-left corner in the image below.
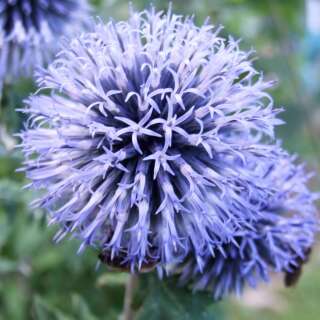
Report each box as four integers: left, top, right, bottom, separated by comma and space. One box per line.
0, 0, 88, 89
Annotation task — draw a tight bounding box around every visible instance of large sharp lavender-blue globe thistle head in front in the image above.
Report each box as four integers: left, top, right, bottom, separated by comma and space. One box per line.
21, 9, 290, 269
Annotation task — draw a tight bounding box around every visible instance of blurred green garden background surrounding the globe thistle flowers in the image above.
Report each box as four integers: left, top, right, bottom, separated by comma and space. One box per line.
0, 0, 320, 320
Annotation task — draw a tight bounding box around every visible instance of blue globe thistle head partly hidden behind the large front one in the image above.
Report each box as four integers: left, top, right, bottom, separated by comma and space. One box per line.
180, 157, 319, 299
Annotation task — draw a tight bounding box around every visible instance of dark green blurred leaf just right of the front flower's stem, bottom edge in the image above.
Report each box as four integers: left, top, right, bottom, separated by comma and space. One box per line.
137, 278, 221, 320
